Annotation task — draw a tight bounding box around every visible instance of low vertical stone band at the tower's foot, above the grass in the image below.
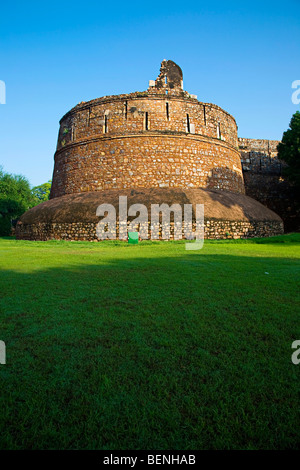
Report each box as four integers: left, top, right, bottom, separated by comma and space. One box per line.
16, 219, 283, 241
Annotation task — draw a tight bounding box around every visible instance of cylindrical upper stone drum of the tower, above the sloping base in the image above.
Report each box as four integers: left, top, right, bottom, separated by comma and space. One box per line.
50, 61, 244, 198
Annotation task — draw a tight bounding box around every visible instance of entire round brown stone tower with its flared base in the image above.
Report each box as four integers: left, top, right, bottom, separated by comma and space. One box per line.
16, 61, 283, 240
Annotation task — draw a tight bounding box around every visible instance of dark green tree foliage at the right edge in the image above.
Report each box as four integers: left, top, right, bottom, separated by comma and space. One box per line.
278, 111, 300, 200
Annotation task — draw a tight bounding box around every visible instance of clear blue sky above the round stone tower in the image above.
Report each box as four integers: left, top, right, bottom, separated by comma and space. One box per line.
0, 0, 300, 185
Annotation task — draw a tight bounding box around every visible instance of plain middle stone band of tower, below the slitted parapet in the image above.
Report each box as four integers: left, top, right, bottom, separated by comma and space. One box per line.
51, 132, 244, 198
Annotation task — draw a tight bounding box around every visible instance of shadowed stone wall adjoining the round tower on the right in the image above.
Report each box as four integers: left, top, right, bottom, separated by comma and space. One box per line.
239, 138, 300, 232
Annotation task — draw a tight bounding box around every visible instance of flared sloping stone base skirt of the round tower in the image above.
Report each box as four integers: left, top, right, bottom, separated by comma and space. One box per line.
17, 189, 283, 240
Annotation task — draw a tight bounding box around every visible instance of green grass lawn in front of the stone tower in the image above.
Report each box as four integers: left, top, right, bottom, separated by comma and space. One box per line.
0, 234, 300, 450
